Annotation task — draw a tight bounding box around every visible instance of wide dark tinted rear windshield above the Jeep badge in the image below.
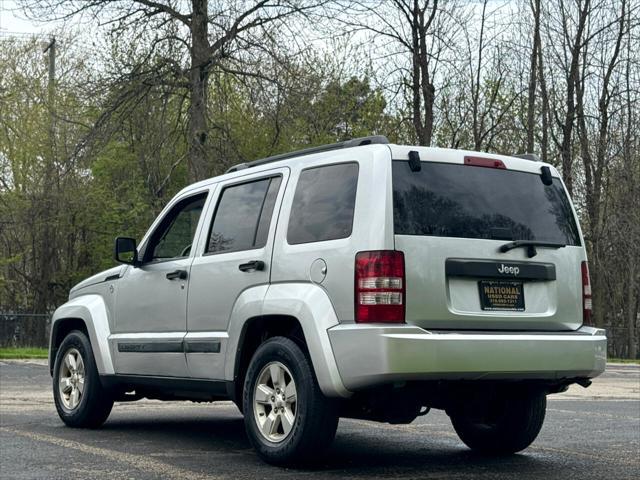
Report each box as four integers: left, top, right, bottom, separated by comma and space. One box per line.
393, 161, 580, 245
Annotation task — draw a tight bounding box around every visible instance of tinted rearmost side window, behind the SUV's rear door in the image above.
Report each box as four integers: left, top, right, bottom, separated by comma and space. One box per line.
287, 163, 358, 245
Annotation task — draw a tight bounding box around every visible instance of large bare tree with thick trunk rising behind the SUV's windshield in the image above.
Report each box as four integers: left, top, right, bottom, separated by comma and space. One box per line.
23, 0, 319, 181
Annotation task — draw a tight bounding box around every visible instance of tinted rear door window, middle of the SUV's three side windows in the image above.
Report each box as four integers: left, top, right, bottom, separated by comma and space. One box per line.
206, 177, 281, 253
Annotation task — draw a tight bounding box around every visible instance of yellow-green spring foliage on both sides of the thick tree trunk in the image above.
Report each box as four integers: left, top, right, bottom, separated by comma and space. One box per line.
0, 38, 395, 313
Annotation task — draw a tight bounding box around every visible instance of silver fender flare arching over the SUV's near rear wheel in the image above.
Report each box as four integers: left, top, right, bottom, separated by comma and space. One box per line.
225, 283, 351, 398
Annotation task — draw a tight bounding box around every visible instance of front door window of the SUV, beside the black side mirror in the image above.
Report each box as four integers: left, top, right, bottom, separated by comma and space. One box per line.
145, 193, 207, 261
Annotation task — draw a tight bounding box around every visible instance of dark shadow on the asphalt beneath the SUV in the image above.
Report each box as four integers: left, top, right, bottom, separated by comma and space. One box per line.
97, 413, 556, 478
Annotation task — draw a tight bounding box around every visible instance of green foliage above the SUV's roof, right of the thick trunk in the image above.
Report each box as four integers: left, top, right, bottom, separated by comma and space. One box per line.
201, 67, 394, 174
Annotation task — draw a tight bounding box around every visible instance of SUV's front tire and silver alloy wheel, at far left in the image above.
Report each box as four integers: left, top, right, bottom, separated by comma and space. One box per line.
53, 330, 113, 428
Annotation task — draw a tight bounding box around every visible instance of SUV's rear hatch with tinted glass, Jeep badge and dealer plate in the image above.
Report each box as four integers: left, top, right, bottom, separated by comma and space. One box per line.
392, 149, 586, 331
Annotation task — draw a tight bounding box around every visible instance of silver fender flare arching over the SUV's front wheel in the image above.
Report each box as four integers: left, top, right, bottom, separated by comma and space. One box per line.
49, 295, 114, 375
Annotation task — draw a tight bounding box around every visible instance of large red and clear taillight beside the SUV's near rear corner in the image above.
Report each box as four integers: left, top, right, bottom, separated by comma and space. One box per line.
354, 250, 405, 323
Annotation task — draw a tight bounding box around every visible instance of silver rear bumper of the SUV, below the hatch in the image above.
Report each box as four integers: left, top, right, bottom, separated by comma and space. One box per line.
328, 324, 607, 391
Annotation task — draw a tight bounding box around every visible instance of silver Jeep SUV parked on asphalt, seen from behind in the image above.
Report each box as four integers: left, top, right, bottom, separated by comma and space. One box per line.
49, 137, 606, 463
